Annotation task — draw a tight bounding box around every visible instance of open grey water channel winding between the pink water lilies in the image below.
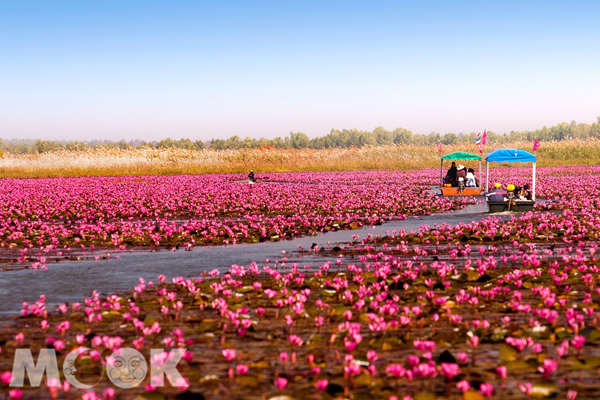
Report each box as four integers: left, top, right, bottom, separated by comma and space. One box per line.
0, 203, 502, 315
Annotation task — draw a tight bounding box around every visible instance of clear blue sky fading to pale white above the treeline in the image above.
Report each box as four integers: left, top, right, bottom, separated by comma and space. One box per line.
0, 0, 600, 140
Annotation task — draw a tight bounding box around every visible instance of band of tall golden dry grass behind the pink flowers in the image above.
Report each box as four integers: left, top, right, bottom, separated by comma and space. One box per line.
0, 139, 600, 177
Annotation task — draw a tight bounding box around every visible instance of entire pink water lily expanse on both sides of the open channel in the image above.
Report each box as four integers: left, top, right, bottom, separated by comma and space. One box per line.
0, 166, 600, 400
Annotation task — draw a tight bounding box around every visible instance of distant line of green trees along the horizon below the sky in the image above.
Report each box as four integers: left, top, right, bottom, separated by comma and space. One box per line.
0, 117, 600, 154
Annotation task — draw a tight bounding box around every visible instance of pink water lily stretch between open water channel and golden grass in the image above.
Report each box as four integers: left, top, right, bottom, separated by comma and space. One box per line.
0, 171, 472, 268
